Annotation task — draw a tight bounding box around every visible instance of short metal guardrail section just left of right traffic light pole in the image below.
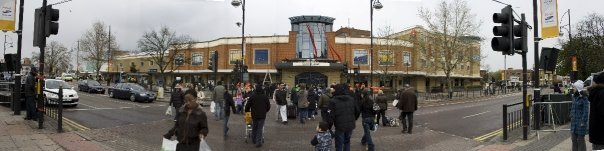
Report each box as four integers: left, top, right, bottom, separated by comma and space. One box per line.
502, 102, 523, 140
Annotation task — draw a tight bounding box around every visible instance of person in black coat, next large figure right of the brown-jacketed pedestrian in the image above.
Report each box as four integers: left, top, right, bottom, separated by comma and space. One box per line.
245, 85, 271, 147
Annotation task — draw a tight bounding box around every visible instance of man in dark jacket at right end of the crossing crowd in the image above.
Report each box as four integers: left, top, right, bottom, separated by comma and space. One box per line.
396, 84, 417, 134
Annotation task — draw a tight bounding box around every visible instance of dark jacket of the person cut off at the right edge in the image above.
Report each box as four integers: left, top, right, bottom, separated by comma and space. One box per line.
587, 84, 604, 145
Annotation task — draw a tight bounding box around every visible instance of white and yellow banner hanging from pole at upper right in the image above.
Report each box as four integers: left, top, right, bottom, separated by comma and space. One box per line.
541, 0, 560, 39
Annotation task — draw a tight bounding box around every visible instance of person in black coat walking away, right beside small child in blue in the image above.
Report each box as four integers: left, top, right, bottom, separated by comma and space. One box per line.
328, 84, 361, 151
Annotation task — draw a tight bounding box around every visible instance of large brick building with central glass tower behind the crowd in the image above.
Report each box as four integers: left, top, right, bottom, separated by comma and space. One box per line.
113, 16, 480, 92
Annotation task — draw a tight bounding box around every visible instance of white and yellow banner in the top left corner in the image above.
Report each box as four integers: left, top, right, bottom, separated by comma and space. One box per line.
0, 0, 17, 31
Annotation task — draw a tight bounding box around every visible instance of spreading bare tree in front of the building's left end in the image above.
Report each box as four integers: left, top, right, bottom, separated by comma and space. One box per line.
138, 26, 193, 87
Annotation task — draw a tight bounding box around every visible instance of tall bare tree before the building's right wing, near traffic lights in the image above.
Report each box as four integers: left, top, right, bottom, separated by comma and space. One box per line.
415, 0, 481, 95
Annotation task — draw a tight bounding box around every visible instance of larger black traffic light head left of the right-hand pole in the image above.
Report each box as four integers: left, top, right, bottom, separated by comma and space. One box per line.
491, 5, 514, 55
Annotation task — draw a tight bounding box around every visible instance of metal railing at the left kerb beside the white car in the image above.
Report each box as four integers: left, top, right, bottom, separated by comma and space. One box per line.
38, 86, 63, 133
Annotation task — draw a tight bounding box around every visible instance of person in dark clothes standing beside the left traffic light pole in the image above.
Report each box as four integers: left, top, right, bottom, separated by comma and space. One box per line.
24, 67, 37, 121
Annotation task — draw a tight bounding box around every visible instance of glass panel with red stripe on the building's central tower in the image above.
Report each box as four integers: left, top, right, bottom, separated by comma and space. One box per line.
292, 23, 331, 58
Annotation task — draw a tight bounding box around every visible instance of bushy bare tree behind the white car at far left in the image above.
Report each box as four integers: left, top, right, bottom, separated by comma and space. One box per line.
32, 41, 71, 77
